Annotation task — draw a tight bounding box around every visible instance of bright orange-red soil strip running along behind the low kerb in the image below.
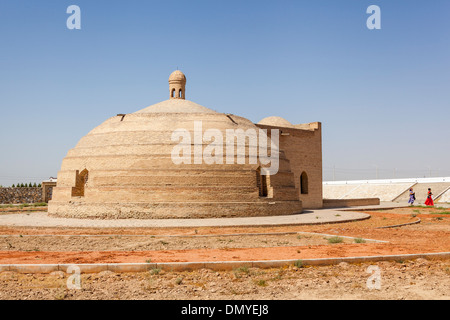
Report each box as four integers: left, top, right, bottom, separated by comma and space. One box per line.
0, 244, 439, 264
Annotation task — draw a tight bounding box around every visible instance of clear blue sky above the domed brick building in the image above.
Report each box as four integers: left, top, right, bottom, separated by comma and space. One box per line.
0, 0, 450, 186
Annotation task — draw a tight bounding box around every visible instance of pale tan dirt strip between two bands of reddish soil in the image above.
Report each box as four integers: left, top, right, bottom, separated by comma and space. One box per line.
0, 233, 373, 252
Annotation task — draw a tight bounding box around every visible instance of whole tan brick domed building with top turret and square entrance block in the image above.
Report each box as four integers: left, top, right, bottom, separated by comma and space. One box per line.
49, 70, 322, 219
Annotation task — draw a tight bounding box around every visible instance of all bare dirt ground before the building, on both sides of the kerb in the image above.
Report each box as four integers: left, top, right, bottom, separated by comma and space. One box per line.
0, 207, 450, 300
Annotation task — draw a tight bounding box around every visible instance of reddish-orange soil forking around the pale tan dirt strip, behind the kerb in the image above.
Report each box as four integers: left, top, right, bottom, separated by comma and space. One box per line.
0, 208, 450, 264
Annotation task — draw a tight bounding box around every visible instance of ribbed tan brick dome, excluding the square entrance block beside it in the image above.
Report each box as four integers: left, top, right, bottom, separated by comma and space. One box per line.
49, 71, 302, 219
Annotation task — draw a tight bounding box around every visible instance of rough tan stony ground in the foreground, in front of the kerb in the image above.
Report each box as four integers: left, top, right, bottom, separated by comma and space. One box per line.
0, 259, 450, 300
